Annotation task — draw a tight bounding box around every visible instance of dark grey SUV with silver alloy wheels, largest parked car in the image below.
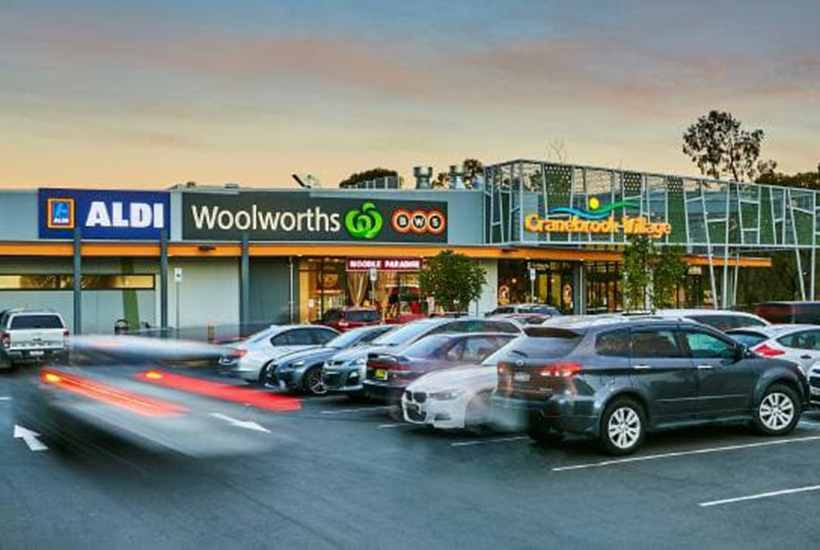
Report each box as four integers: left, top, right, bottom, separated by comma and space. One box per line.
493, 319, 809, 454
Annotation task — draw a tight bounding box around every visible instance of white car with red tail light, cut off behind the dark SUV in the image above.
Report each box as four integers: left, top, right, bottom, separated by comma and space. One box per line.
726, 325, 820, 370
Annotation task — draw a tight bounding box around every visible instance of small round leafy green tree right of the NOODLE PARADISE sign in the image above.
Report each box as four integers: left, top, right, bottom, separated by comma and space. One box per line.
419, 250, 487, 311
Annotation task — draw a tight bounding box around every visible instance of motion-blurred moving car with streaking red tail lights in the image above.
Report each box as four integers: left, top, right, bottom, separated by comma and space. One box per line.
12, 336, 299, 460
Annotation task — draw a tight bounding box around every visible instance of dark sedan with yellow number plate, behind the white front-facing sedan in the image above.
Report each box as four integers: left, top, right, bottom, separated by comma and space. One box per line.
364, 332, 517, 403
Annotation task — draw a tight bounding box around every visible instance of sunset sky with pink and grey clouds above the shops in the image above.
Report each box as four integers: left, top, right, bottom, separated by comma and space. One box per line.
0, 0, 820, 188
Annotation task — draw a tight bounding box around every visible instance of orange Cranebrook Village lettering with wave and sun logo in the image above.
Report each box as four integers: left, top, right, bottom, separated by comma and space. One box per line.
524, 197, 672, 239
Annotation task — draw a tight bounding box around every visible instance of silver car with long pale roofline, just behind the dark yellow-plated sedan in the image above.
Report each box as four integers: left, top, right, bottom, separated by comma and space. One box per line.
322, 317, 521, 396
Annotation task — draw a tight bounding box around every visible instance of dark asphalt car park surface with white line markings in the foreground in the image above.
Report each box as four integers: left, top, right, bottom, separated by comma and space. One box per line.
0, 366, 820, 548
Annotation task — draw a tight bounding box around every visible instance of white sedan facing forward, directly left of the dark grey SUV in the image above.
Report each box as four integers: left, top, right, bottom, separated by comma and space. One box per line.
401, 342, 514, 430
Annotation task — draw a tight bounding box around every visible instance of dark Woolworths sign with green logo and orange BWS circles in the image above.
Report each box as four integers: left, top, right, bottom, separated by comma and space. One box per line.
182, 191, 448, 243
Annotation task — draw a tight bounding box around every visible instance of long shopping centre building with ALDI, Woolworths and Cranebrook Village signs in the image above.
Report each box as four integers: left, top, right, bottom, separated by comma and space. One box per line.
0, 160, 820, 333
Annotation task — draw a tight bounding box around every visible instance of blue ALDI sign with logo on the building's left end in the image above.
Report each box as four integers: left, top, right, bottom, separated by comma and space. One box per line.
38, 189, 171, 240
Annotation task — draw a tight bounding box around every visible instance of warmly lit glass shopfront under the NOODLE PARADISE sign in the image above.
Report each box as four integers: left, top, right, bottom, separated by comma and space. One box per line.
299, 258, 426, 323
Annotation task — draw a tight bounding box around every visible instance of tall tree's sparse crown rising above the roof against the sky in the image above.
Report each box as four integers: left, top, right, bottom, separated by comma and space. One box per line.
683, 111, 773, 181
